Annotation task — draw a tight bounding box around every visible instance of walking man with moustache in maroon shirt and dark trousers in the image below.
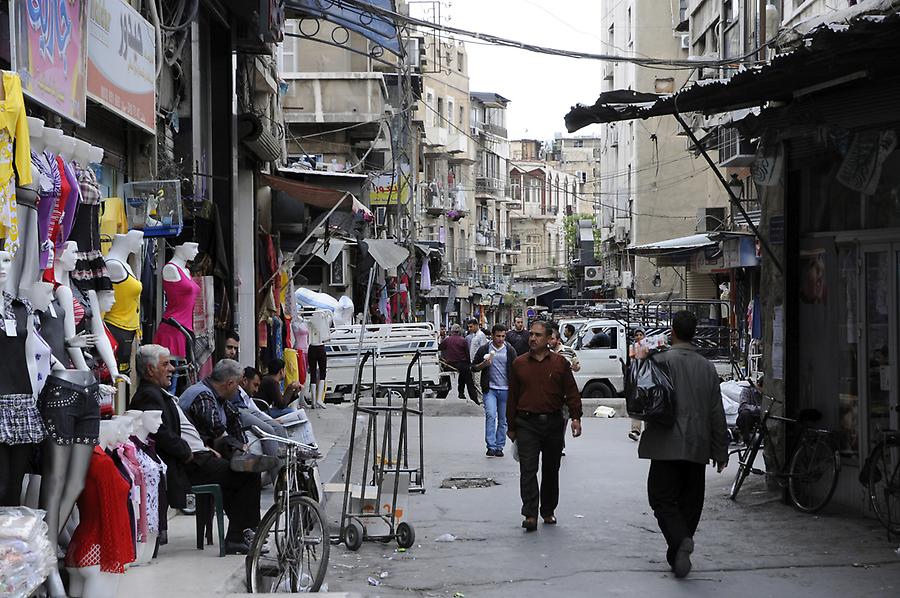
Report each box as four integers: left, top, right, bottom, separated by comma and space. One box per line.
506, 320, 581, 532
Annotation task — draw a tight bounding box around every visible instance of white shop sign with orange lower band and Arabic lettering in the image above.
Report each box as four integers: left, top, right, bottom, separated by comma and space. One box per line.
87, 0, 156, 134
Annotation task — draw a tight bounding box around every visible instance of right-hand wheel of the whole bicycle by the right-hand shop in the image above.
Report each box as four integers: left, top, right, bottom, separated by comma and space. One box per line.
788, 436, 841, 513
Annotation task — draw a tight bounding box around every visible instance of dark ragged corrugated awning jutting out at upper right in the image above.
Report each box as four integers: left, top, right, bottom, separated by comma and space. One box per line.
566, 13, 900, 133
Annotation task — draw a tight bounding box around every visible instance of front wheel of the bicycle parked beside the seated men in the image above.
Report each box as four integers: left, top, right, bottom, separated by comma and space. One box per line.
247, 494, 331, 594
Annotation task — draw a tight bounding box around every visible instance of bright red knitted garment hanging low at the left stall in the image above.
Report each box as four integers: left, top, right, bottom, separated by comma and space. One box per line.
66, 446, 135, 573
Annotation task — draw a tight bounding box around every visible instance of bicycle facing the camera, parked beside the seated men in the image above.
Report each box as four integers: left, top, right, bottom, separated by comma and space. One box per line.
246, 426, 331, 594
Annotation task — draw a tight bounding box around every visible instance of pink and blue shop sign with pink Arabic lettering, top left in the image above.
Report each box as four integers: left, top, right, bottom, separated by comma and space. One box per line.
12, 0, 88, 126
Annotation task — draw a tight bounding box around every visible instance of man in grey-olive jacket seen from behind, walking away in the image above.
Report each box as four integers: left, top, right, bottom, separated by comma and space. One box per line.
638, 311, 728, 578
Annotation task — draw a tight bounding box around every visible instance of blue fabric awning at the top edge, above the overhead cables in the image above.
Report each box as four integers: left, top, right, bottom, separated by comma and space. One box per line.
284, 0, 401, 57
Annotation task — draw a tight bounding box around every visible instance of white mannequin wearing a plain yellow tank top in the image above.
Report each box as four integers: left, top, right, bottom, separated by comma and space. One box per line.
103, 230, 144, 374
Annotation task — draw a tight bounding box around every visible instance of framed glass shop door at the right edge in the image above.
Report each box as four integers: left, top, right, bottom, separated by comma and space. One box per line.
859, 243, 900, 452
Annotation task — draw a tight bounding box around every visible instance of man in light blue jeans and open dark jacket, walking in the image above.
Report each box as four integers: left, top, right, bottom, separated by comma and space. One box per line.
472, 324, 516, 457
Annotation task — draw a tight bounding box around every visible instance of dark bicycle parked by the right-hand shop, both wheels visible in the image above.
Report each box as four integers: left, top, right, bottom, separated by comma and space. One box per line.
729, 395, 841, 513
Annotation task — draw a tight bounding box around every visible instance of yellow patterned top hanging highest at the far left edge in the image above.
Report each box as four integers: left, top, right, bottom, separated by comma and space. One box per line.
0, 71, 32, 255
